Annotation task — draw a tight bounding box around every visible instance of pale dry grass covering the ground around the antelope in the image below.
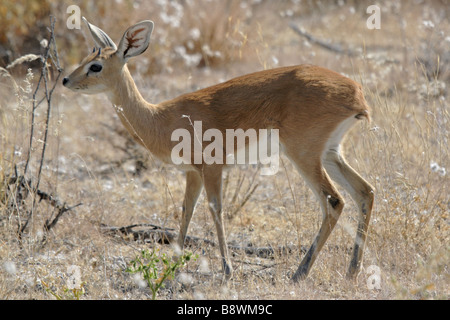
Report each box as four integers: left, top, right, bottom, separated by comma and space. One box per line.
0, 1, 450, 299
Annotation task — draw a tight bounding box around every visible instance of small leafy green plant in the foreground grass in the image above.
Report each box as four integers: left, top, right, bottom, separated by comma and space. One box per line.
125, 249, 196, 300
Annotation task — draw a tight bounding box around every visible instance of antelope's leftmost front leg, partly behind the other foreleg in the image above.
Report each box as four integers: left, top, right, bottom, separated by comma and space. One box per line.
178, 171, 203, 250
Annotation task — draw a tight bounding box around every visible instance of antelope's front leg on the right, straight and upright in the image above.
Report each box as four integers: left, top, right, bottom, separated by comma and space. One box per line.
203, 166, 233, 280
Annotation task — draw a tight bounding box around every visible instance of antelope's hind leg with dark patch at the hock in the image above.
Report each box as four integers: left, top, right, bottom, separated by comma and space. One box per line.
291, 157, 344, 281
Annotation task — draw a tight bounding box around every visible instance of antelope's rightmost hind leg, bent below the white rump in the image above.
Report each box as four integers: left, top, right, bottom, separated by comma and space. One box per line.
324, 149, 374, 278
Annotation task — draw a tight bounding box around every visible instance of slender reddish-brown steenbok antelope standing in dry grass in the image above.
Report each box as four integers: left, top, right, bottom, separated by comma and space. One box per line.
63, 18, 374, 281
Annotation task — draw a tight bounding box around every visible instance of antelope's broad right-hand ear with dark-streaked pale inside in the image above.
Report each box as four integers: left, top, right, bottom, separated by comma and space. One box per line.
116, 20, 154, 62
